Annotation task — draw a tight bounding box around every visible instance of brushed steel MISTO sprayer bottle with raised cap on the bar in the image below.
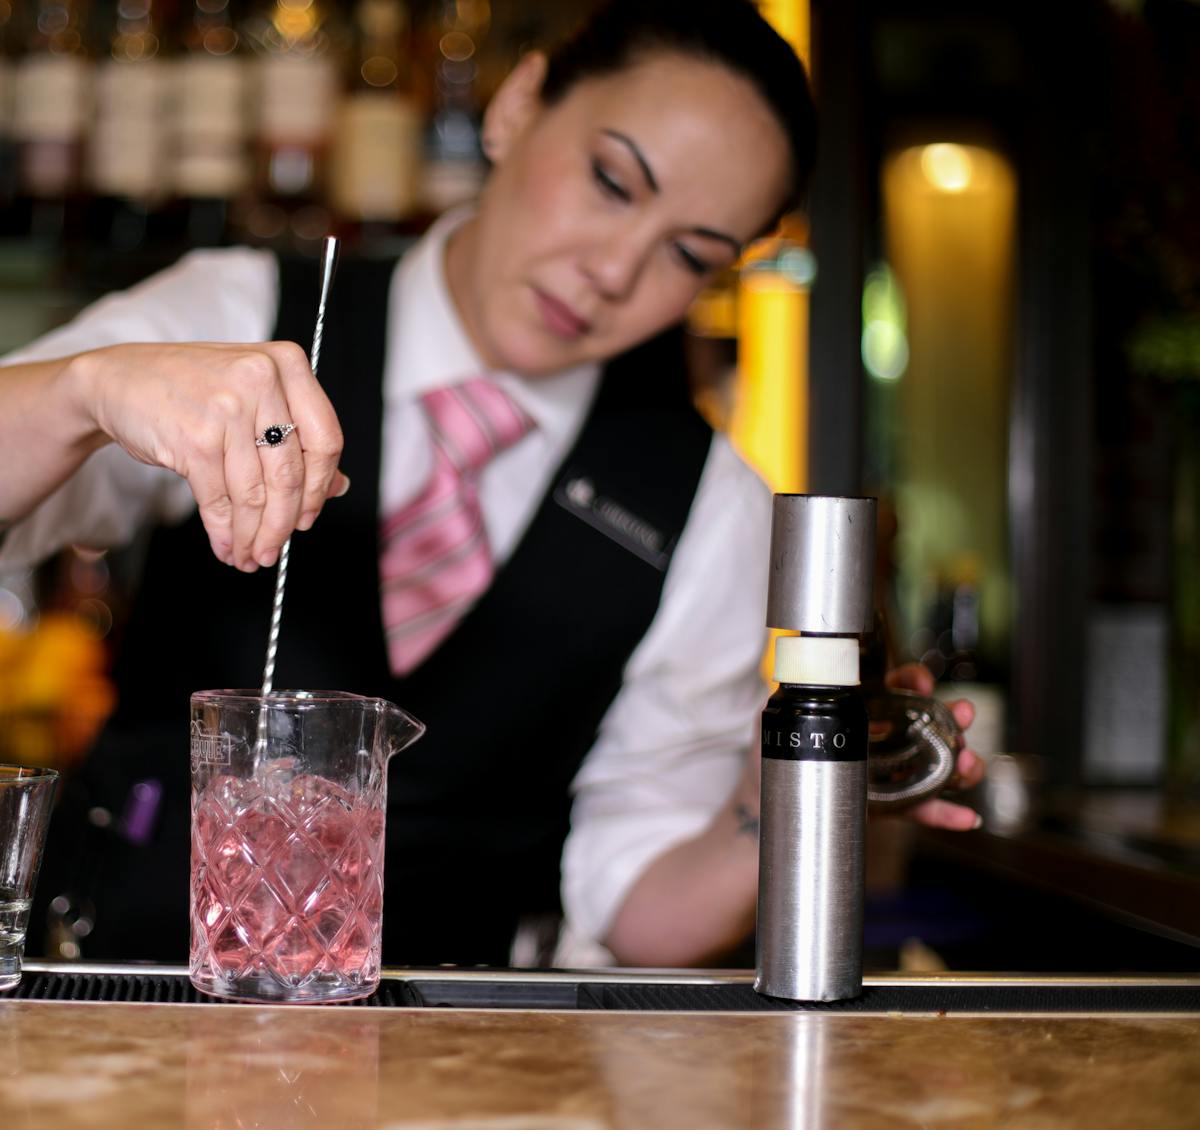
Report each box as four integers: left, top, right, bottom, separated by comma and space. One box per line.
755, 494, 875, 1000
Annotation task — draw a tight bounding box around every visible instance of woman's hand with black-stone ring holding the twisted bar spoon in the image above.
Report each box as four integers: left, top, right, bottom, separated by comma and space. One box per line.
68, 342, 349, 572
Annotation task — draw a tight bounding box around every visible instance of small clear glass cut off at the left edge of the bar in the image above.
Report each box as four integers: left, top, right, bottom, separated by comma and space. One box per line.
0, 765, 59, 990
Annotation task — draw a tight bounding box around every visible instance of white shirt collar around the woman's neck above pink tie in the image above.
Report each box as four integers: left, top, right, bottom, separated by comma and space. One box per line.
384, 209, 600, 439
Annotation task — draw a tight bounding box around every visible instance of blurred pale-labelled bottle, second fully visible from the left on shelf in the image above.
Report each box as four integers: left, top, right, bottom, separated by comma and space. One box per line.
86, 0, 169, 265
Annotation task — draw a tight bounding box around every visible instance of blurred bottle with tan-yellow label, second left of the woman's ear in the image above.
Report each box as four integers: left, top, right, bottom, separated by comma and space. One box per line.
330, 0, 422, 245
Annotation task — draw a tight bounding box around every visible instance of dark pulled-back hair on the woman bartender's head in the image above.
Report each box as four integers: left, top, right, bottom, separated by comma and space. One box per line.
541, 0, 816, 219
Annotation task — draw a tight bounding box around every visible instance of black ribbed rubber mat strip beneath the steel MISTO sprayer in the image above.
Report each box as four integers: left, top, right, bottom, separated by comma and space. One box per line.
578, 984, 1200, 1014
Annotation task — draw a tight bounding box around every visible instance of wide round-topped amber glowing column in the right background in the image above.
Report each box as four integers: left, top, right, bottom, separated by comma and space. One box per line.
883, 144, 1016, 653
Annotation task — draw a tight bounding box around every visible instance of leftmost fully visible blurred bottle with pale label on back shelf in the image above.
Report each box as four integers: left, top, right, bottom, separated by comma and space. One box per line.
13, 0, 91, 242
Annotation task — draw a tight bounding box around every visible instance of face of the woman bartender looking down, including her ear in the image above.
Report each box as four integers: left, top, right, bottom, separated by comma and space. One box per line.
446, 54, 788, 377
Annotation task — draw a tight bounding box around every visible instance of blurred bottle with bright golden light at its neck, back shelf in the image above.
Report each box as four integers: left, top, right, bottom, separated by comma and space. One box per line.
238, 0, 342, 251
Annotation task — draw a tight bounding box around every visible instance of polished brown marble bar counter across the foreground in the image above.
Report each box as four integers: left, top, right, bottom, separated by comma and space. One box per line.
0, 966, 1200, 1130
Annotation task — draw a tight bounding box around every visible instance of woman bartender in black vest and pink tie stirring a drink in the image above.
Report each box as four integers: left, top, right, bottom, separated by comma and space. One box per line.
0, 0, 982, 966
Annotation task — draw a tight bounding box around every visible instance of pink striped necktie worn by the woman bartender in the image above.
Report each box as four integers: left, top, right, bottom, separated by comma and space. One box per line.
379, 377, 534, 675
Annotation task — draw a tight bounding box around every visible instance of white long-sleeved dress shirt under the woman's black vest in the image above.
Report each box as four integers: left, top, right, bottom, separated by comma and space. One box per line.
0, 216, 770, 939
